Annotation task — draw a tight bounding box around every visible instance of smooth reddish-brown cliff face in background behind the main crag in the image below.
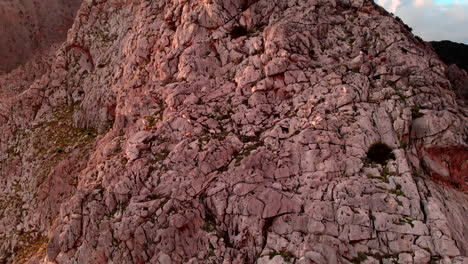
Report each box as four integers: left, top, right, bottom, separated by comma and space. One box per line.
0, 0, 82, 73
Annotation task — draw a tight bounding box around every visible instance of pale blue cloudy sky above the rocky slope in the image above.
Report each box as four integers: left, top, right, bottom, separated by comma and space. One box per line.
375, 0, 468, 44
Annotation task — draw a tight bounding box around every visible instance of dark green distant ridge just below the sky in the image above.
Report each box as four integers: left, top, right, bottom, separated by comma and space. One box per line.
429, 40, 468, 71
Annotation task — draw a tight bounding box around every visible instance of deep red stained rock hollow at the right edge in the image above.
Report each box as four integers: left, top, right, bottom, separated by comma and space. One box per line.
422, 146, 468, 192
